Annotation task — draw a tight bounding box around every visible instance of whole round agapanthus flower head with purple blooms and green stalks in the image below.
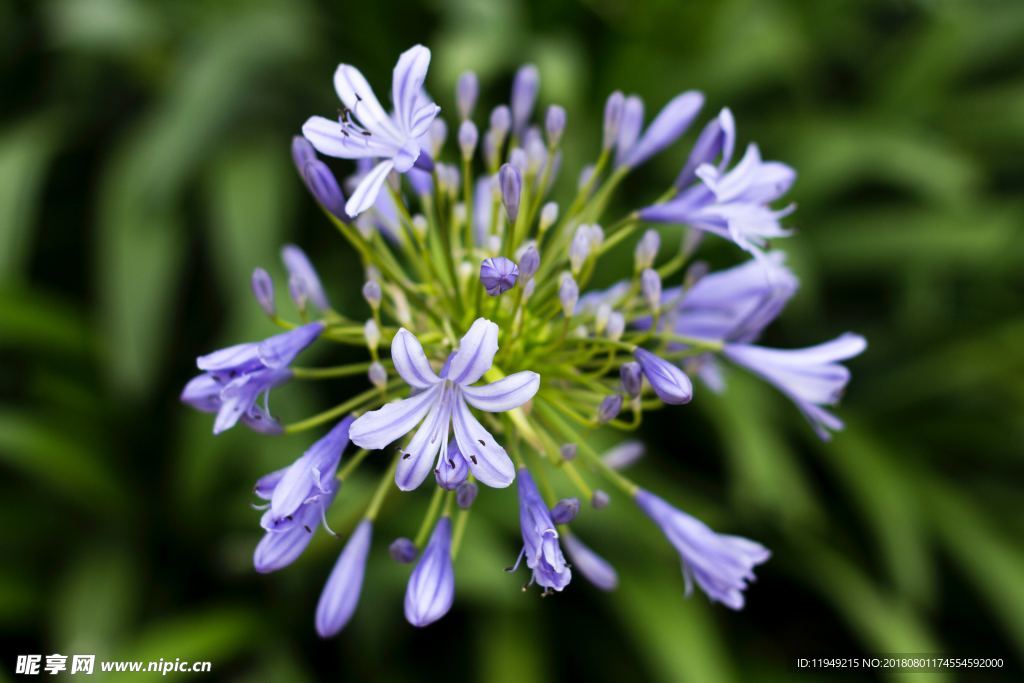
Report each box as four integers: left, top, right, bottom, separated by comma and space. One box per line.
181, 45, 865, 637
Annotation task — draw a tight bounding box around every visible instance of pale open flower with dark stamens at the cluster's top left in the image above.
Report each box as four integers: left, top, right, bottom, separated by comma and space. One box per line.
302, 45, 440, 217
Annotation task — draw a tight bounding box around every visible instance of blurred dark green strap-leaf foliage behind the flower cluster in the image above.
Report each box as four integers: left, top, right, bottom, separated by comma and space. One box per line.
0, 0, 1024, 683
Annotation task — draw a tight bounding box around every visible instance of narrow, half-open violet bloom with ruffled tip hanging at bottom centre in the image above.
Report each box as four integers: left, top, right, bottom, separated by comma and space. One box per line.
516, 468, 572, 591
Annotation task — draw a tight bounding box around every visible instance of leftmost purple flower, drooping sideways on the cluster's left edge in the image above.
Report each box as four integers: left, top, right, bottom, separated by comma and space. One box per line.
181, 323, 324, 434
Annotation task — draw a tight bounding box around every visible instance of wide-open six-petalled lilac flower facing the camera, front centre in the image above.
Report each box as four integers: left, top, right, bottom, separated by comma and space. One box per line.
349, 317, 541, 490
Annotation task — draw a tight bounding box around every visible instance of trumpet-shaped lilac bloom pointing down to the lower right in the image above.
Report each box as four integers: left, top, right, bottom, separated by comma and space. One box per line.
636, 488, 771, 609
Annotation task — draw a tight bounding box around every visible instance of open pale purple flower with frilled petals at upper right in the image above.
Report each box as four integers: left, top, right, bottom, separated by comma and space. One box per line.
640, 144, 797, 256
